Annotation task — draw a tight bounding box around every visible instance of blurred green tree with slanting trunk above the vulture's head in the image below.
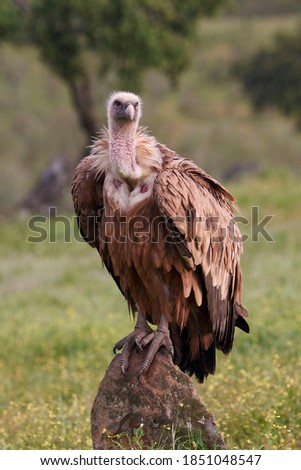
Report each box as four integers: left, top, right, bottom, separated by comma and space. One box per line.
0, 0, 225, 138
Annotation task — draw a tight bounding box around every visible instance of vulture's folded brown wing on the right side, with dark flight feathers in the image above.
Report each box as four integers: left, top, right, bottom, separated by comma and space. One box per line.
154, 151, 248, 364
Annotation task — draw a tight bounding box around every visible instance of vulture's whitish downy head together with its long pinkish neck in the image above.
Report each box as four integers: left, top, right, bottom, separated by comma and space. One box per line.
107, 91, 142, 183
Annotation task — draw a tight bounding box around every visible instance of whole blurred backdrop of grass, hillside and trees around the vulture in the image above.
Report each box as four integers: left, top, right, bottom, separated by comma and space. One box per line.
0, 0, 301, 449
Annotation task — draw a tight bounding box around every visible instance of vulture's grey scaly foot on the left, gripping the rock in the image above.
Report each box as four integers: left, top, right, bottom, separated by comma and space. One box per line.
113, 310, 155, 374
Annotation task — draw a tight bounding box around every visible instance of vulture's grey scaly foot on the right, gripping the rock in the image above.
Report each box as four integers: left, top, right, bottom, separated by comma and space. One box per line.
139, 315, 174, 376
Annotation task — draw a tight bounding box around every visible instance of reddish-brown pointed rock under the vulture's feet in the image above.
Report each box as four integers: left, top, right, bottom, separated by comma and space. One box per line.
91, 349, 224, 449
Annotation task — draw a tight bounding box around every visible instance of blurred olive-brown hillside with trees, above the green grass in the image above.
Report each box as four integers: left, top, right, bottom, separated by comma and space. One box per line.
0, 0, 301, 212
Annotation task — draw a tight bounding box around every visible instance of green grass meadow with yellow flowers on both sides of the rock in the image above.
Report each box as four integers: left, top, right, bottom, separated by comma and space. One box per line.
0, 171, 301, 449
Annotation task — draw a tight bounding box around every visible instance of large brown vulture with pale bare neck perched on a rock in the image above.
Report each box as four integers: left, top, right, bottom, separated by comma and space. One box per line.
71, 91, 249, 382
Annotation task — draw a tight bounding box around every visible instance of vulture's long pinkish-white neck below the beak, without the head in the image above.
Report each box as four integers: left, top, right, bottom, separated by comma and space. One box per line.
109, 121, 142, 183
